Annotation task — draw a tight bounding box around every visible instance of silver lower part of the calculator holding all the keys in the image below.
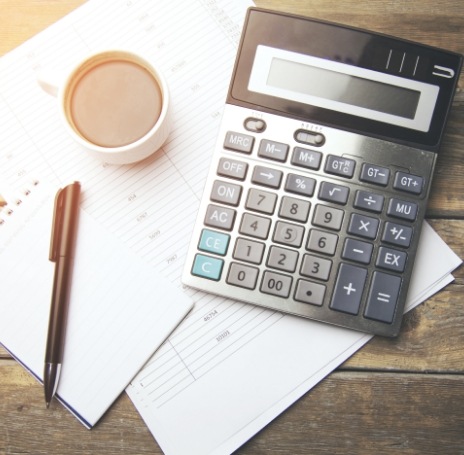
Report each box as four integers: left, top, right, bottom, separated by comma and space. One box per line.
183, 106, 434, 336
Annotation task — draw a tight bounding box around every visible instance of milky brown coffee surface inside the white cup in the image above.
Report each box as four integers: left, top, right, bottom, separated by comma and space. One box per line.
66, 58, 163, 148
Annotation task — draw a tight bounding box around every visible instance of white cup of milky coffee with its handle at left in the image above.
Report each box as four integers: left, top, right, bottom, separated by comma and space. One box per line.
38, 50, 171, 164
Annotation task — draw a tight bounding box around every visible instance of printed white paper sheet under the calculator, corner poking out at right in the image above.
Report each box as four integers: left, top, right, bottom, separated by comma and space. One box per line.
127, 223, 461, 455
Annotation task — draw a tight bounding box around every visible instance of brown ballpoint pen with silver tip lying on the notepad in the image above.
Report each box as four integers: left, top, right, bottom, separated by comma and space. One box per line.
44, 182, 81, 408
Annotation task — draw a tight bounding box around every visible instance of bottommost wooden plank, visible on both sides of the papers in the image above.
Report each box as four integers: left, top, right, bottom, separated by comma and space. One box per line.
0, 363, 464, 455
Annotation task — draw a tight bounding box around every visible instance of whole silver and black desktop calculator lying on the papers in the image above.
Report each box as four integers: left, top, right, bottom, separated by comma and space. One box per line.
182, 8, 462, 337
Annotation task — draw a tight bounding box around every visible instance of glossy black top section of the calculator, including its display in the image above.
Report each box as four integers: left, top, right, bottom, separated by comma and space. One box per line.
227, 8, 462, 151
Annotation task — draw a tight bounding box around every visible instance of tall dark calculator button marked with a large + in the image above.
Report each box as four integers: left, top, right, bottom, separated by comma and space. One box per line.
330, 263, 367, 314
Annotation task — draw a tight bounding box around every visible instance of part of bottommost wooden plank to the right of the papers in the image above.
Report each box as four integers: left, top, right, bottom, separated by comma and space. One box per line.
237, 372, 464, 455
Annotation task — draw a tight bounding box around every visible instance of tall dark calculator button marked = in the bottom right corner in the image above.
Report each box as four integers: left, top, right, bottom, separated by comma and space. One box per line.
364, 272, 401, 324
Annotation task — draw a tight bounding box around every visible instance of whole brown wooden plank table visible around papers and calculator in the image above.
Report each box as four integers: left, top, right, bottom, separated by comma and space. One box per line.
0, 0, 464, 455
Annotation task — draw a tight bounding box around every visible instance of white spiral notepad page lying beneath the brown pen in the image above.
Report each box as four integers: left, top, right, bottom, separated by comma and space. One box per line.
0, 181, 192, 427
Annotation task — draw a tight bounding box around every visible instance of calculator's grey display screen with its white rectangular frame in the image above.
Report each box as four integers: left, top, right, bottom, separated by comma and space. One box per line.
248, 45, 439, 132
